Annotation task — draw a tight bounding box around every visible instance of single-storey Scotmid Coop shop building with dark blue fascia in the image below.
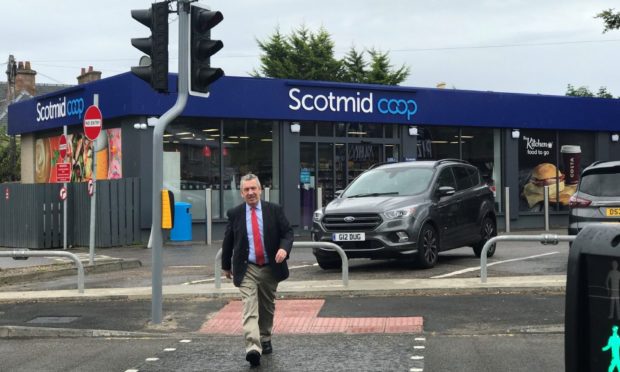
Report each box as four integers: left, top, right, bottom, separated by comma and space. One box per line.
9, 73, 620, 240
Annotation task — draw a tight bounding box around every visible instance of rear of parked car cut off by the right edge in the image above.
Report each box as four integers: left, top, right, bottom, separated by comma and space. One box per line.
568, 161, 620, 235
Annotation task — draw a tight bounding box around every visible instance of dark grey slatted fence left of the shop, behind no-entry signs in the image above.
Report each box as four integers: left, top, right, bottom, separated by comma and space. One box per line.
0, 178, 140, 249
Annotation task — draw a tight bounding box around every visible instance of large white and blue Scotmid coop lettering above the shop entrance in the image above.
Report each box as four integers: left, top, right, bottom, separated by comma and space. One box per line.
288, 88, 418, 120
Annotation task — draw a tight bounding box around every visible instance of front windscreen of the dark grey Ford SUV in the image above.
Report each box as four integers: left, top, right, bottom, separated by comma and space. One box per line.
343, 168, 433, 198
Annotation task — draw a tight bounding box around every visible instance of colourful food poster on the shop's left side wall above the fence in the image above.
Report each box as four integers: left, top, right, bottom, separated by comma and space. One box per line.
35, 128, 123, 183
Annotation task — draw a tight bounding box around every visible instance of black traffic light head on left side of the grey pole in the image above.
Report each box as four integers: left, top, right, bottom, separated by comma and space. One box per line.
131, 1, 168, 92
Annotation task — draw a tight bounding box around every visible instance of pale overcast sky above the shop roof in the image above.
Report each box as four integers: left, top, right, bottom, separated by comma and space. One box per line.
0, 0, 620, 97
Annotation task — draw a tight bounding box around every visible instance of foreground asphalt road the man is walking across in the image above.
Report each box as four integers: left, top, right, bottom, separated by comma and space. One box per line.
0, 293, 564, 371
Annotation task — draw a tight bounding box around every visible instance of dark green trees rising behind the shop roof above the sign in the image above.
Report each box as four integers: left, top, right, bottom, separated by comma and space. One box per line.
252, 26, 409, 85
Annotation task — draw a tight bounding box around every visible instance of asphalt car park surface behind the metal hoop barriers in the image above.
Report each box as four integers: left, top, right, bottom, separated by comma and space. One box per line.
0, 235, 568, 291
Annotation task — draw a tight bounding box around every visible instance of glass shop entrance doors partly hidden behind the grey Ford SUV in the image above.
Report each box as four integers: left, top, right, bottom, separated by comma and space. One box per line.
299, 142, 382, 230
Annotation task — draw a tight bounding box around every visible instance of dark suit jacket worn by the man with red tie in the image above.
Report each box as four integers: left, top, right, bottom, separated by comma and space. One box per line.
222, 200, 293, 287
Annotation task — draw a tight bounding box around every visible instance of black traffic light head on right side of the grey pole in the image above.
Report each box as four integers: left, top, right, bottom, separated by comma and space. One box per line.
189, 5, 224, 96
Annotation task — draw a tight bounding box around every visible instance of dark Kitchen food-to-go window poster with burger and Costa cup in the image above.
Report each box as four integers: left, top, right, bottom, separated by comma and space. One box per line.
519, 131, 580, 212
